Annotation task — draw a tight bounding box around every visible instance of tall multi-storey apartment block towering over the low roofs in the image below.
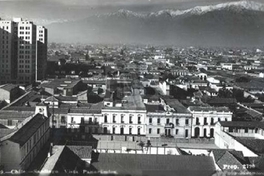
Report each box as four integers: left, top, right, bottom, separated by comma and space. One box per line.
0, 18, 47, 84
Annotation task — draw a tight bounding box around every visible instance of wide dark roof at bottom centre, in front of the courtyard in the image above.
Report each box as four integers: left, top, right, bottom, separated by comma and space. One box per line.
91, 153, 215, 176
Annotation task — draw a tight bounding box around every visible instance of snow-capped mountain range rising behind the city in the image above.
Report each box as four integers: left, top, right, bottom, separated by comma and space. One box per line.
47, 1, 264, 46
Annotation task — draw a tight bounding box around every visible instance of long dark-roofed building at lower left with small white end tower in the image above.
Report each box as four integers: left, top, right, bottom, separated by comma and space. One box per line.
0, 104, 50, 171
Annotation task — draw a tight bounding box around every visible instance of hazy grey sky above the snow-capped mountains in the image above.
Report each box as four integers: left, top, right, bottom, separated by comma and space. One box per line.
0, 0, 264, 24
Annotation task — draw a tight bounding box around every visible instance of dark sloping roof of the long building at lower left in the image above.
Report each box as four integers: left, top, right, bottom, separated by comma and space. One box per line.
9, 114, 47, 146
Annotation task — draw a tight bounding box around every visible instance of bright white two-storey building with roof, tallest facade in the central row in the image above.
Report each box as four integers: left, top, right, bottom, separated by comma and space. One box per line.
100, 95, 146, 135
